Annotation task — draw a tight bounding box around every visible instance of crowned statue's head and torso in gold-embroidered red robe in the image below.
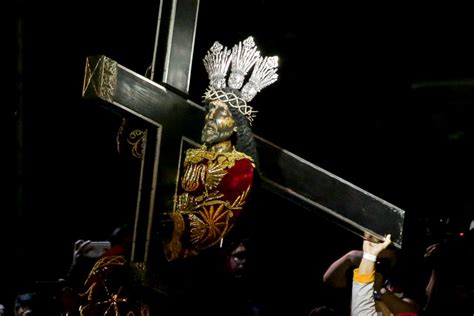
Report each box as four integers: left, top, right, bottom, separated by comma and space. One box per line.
165, 37, 278, 260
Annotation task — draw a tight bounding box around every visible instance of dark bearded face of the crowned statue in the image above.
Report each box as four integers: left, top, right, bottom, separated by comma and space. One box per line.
201, 100, 235, 145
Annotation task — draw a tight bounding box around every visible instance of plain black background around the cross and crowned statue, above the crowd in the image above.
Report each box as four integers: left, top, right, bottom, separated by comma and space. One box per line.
5, 0, 474, 315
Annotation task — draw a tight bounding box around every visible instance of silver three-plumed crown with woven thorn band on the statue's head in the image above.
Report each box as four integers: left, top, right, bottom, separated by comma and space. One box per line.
203, 36, 278, 122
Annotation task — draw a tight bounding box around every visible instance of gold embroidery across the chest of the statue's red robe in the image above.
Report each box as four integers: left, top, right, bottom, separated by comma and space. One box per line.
165, 146, 255, 261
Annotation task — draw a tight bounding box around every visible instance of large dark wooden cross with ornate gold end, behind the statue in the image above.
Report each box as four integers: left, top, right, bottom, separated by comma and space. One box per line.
83, 0, 405, 270
